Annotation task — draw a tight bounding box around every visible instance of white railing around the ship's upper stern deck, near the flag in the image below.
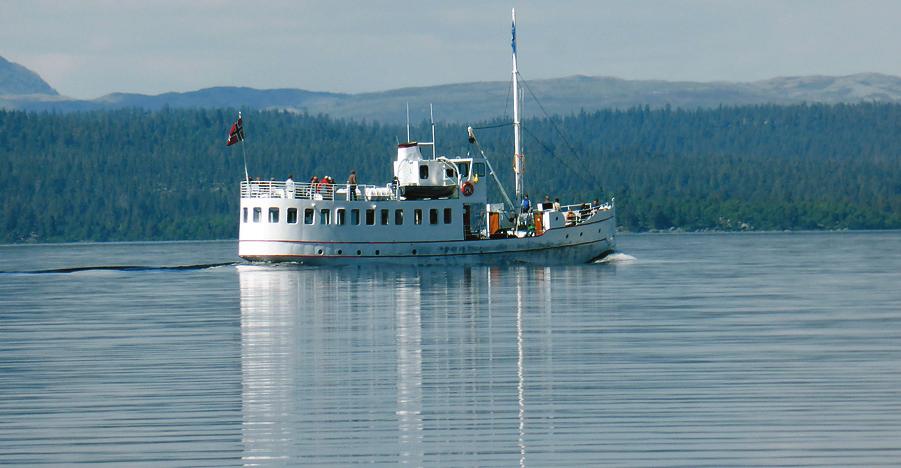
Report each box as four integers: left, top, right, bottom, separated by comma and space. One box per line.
241, 180, 398, 201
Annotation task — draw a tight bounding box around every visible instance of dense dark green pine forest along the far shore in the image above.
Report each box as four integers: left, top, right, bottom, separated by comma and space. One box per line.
0, 103, 901, 243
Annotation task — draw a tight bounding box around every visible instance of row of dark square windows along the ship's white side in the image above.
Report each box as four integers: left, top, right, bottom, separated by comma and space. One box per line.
243, 207, 454, 226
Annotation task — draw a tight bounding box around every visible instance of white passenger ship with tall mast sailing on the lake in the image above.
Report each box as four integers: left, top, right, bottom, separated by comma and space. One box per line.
238, 12, 616, 265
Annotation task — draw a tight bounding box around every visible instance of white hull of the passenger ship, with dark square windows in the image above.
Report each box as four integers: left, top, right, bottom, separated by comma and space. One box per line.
238, 193, 616, 265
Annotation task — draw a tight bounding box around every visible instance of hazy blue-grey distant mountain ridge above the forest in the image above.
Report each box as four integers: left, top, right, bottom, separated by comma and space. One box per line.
0, 58, 901, 123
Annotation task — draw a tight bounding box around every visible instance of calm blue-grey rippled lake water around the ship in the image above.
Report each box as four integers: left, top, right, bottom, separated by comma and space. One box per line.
0, 232, 901, 467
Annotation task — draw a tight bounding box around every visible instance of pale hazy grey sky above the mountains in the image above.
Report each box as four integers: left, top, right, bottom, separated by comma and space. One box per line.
0, 0, 901, 98
